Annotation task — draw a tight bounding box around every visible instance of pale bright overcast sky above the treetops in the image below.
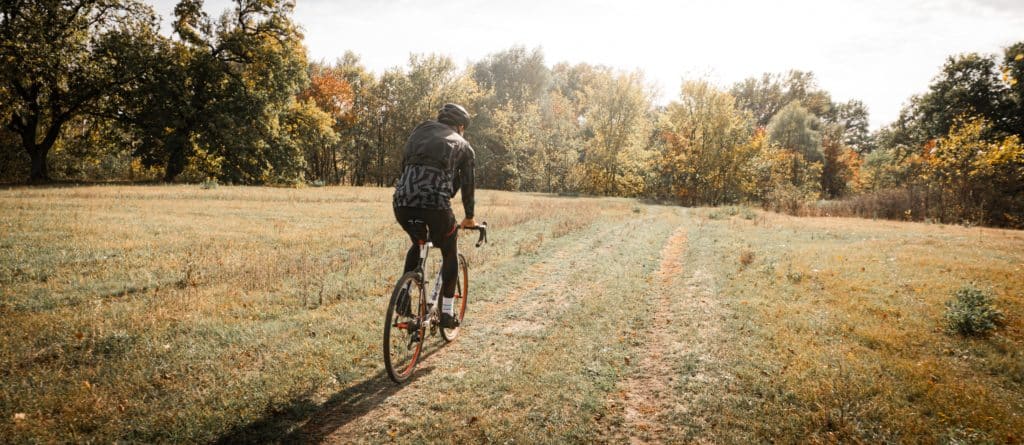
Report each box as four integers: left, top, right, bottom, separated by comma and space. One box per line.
144, 0, 1024, 129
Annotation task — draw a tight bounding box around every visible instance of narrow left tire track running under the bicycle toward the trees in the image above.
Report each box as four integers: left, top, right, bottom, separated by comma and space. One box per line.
295, 214, 638, 443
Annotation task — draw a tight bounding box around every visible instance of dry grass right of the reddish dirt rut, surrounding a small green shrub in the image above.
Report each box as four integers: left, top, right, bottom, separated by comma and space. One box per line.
690, 208, 1024, 443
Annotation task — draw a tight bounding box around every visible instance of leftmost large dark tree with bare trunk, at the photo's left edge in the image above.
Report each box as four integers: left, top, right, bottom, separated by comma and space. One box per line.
0, 0, 158, 181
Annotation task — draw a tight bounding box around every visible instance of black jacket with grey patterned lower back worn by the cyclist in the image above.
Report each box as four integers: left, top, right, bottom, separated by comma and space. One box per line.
392, 121, 476, 218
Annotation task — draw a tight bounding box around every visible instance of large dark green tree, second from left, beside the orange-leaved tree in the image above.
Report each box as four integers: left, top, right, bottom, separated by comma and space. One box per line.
125, 0, 307, 183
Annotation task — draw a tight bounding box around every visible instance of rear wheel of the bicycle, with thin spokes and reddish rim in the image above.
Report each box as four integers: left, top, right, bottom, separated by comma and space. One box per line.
384, 272, 427, 384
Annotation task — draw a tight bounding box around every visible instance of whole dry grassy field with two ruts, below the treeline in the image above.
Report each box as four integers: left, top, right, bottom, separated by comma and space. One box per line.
0, 186, 1024, 443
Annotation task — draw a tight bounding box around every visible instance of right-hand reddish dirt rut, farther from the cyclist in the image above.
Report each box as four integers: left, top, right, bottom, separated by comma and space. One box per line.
607, 214, 728, 444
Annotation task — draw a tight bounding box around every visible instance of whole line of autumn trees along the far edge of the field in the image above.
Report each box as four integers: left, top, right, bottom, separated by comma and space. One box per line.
0, 0, 1024, 227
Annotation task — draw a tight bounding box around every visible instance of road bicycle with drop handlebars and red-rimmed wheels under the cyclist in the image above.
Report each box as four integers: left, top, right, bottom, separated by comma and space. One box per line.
384, 222, 487, 384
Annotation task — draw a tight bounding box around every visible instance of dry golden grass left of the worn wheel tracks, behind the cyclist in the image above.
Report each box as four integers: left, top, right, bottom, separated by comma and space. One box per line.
0, 186, 628, 442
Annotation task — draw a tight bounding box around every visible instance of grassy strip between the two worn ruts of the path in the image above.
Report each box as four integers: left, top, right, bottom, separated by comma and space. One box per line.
372, 213, 671, 443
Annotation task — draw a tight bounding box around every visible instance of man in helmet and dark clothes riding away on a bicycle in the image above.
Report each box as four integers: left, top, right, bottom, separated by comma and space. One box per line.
392, 103, 476, 328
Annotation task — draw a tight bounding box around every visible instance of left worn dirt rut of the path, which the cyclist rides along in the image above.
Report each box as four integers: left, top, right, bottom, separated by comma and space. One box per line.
294, 218, 643, 443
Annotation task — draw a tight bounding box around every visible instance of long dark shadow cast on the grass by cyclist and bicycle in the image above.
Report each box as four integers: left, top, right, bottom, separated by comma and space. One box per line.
215, 346, 443, 444
